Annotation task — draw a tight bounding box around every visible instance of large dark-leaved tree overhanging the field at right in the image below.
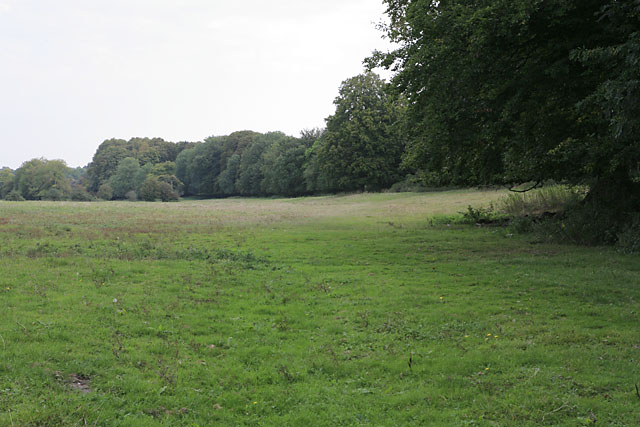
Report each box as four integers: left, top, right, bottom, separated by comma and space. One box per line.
369, 0, 640, 194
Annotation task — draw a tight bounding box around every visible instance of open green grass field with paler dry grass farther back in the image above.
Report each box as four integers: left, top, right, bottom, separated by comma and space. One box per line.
0, 191, 640, 426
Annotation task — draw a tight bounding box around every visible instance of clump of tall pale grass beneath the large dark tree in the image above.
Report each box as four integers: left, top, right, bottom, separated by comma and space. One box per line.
498, 185, 586, 218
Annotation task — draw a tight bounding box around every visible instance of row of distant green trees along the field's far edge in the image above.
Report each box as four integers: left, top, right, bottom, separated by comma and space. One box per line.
0, 72, 407, 201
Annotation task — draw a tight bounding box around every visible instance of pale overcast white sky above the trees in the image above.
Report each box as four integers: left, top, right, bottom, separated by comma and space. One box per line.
0, 0, 388, 169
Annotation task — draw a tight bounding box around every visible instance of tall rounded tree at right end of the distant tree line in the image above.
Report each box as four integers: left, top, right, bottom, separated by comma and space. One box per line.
318, 72, 405, 191
